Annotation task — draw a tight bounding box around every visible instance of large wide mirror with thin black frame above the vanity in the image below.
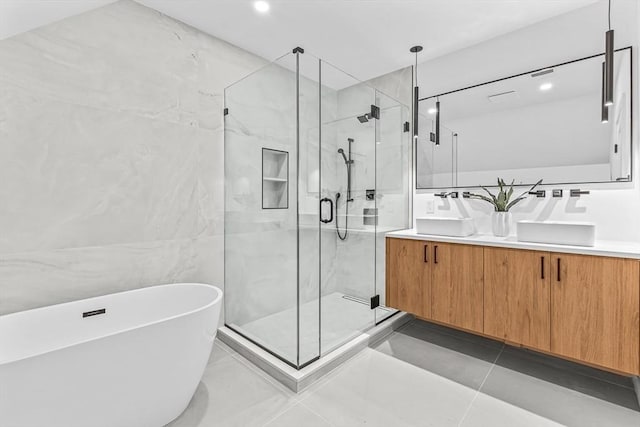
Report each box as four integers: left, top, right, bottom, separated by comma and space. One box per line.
416, 47, 631, 189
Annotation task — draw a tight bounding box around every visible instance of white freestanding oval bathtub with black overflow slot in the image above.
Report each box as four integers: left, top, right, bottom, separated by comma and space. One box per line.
0, 283, 222, 427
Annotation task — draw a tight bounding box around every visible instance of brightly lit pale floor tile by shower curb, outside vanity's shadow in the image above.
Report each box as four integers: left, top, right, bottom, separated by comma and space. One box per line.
302, 349, 475, 427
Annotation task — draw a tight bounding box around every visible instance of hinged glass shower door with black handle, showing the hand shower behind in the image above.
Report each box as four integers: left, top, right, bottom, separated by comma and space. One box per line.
320, 62, 379, 354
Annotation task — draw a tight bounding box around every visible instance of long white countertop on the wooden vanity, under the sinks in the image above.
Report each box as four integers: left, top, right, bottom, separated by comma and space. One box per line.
386, 229, 640, 259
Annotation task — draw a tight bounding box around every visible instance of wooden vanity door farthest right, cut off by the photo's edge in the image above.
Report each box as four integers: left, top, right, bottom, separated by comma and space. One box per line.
551, 254, 640, 374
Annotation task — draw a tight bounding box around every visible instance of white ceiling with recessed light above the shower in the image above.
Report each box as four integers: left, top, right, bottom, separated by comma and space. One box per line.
0, 0, 598, 80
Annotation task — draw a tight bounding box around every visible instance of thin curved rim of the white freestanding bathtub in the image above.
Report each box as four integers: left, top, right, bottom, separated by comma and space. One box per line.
0, 282, 224, 367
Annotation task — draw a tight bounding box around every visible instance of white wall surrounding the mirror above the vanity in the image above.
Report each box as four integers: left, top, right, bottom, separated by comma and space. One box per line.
414, 0, 640, 241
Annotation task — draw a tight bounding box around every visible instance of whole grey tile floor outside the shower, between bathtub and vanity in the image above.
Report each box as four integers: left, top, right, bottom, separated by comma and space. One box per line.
169, 320, 640, 427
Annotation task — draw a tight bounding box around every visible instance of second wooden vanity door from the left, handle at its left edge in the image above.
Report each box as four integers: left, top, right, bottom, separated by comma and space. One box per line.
431, 242, 484, 333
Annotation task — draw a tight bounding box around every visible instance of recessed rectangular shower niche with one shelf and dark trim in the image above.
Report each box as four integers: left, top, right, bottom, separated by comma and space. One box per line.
262, 148, 289, 209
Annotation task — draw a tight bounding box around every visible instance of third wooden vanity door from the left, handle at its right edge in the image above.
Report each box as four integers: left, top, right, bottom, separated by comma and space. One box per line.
484, 247, 551, 351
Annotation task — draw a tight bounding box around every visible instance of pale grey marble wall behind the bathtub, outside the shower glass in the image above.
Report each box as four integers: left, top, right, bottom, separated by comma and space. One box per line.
0, 0, 266, 314
